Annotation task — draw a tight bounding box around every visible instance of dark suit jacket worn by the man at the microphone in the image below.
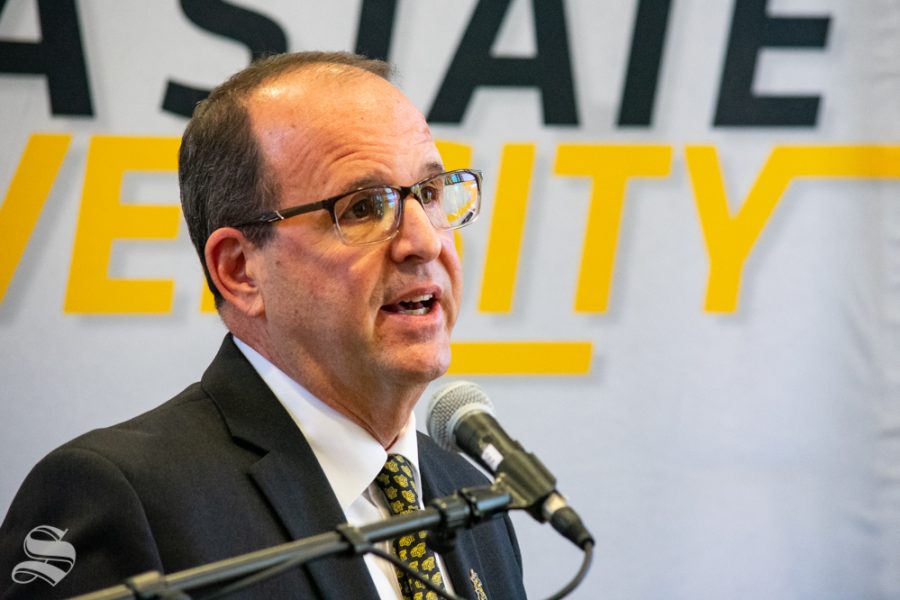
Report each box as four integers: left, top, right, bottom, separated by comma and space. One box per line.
0, 336, 525, 600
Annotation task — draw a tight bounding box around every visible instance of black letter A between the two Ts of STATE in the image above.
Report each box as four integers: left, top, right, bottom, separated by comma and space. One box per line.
428, 0, 578, 125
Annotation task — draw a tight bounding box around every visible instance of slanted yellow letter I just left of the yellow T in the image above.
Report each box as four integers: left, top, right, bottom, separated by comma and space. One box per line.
479, 144, 536, 313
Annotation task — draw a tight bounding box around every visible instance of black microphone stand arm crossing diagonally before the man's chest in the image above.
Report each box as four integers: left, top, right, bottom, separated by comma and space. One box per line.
70, 486, 512, 600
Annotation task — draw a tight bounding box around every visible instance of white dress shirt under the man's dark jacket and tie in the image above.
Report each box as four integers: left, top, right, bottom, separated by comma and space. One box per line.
234, 337, 452, 600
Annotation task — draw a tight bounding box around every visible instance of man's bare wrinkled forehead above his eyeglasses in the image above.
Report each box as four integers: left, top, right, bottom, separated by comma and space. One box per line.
248, 69, 440, 200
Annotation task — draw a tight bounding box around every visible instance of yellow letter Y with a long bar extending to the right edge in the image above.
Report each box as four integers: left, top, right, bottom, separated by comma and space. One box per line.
685, 146, 900, 312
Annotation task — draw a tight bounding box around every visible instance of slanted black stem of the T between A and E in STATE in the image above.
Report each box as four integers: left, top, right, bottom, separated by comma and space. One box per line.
619, 0, 672, 125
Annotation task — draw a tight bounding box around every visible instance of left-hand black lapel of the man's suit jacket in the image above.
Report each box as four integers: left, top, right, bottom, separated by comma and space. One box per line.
201, 335, 377, 598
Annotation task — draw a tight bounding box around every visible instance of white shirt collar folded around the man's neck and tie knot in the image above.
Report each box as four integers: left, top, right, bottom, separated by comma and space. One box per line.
234, 337, 421, 510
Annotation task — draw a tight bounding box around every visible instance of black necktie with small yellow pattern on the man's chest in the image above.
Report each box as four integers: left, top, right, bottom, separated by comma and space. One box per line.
375, 454, 446, 600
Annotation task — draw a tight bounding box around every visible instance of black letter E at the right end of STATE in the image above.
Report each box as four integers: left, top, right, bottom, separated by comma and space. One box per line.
714, 0, 830, 127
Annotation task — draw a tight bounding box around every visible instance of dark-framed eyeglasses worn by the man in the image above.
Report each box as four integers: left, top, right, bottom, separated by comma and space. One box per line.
231, 169, 482, 246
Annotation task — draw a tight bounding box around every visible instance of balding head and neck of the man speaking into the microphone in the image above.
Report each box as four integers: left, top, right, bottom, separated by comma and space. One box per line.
180, 54, 461, 444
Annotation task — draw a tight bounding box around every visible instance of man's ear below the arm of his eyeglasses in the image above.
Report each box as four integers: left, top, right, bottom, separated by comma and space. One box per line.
204, 227, 265, 317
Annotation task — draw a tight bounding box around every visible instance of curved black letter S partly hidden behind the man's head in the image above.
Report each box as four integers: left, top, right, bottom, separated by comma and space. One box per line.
162, 0, 287, 117
